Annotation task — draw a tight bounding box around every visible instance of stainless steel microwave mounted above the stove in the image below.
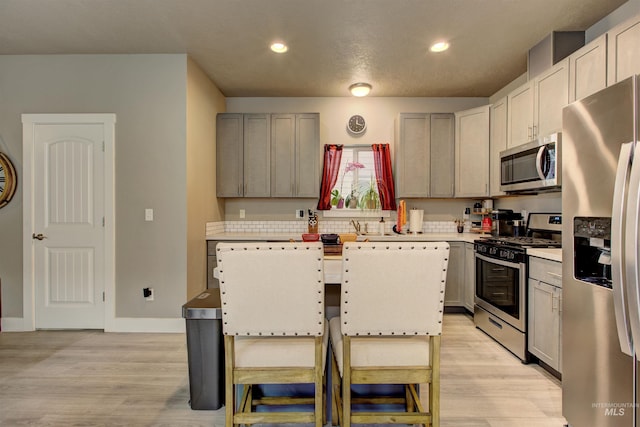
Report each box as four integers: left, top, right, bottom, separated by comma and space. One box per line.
500, 132, 562, 193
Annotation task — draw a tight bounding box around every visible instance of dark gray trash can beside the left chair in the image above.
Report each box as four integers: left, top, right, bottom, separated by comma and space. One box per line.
182, 289, 224, 409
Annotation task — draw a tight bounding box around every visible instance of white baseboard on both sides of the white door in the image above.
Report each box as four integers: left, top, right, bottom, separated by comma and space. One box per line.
0, 317, 186, 334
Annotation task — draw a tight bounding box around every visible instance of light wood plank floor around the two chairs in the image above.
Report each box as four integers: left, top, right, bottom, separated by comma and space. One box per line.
0, 314, 565, 427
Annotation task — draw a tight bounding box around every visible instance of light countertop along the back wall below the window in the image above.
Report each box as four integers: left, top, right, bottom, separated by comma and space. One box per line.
206, 232, 482, 243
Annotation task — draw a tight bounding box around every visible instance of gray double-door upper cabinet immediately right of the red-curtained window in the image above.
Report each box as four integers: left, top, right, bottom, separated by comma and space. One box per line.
395, 113, 455, 197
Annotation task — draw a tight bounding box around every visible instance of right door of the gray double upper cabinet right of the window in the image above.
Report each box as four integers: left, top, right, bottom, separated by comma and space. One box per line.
429, 114, 455, 197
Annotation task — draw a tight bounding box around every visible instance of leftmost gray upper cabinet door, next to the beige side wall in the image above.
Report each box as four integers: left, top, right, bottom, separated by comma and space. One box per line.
216, 113, 244, 197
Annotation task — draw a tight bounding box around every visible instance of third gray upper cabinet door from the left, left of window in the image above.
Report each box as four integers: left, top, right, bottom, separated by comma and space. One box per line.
271, 114, 296, 197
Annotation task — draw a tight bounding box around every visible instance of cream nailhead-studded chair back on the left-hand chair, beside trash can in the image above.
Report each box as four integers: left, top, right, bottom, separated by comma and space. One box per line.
216, 242, 325, 336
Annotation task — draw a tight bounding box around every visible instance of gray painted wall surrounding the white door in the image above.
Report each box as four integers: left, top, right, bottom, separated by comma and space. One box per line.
0, 55, 187, 318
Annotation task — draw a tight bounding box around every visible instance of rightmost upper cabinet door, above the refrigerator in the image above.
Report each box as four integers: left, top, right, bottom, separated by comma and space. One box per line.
607, 17, 640, 86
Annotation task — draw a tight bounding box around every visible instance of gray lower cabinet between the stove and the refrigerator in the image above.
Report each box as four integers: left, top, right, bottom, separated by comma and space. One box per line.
528, 257, 562, 373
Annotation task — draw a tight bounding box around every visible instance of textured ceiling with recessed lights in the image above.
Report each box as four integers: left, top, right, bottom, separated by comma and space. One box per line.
0, 0, 625, 97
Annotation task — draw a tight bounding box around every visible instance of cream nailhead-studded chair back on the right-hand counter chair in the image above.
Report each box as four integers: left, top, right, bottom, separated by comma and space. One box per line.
340, 242, 449, 336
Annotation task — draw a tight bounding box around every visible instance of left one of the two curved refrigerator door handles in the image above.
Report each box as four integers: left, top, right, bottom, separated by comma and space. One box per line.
611, 142, 633, 356
